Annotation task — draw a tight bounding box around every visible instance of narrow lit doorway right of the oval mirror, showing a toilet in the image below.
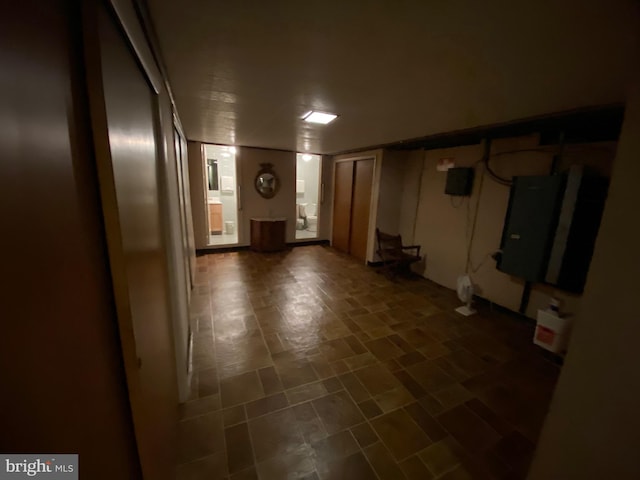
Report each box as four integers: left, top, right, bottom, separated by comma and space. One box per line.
296, 153, 321, 240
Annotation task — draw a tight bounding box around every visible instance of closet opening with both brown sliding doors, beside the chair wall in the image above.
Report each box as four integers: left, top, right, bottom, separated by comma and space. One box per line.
331, 158, 374, 261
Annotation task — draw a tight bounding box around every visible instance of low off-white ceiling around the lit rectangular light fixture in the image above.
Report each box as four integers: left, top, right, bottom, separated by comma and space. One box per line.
147, 0, 640, 153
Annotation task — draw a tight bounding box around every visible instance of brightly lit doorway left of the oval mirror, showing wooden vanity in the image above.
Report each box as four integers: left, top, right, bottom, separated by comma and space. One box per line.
204, 145, 238, 246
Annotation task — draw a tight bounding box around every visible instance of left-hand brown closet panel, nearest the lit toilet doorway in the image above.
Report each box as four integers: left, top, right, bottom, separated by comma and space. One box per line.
331, 162, 353, 253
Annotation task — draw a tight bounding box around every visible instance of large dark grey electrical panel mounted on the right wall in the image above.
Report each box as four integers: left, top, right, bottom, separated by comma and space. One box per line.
497, 167, 607, 293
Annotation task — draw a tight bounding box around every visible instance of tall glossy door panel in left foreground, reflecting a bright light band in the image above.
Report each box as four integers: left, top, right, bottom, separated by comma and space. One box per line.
86, 7, 178, 480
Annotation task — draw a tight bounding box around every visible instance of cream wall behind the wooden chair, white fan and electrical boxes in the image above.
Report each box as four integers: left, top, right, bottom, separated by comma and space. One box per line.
398, 135, 615, 318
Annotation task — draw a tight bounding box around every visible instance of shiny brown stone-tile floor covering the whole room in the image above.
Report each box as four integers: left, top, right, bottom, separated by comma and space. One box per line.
177, 246, 558, 480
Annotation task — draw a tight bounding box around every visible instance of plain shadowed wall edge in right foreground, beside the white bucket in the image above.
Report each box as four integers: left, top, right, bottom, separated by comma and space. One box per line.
529, 84, 640, 480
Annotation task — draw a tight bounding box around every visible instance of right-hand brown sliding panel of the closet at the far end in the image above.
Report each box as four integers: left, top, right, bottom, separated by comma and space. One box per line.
349, 159, 373, 261
